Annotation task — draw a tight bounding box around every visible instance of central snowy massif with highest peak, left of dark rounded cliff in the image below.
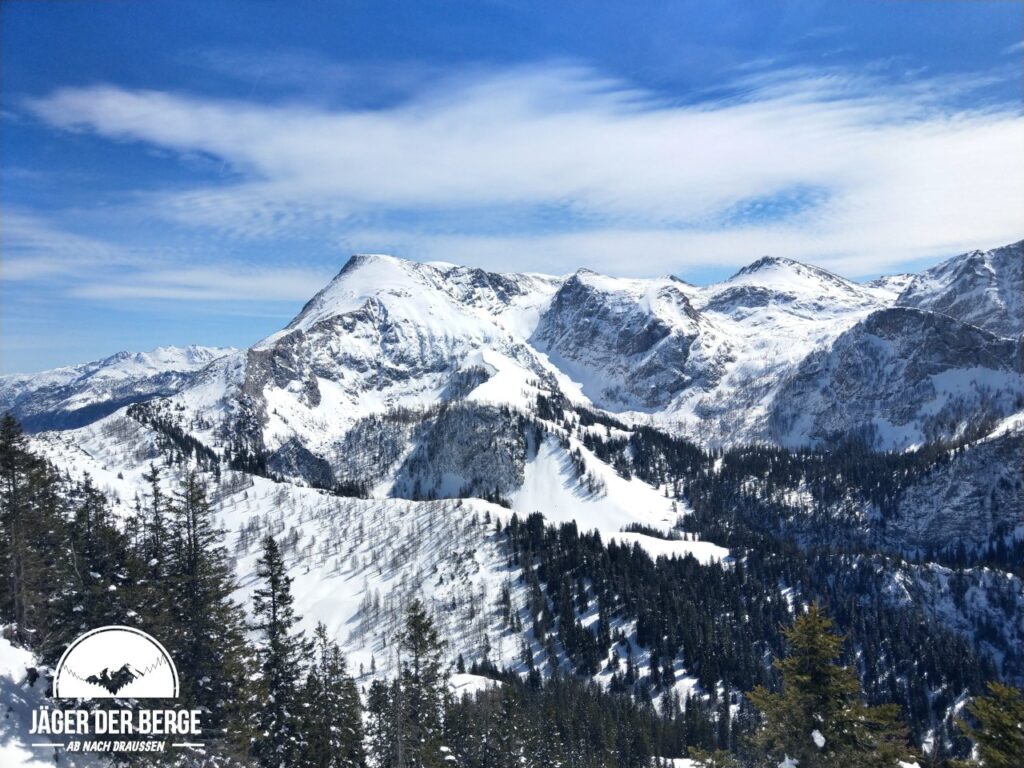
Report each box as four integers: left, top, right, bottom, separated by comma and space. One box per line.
146, 249, 905, 457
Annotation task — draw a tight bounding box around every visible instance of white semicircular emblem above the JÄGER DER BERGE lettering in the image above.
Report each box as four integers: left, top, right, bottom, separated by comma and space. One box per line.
53, 627, 178, 698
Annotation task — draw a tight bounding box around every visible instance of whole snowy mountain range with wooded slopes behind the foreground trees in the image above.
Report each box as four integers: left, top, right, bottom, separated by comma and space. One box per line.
0, 241, 1024, 741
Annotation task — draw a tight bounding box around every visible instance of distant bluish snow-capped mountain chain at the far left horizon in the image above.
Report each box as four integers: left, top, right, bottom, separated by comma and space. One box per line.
0, 345, 233, 431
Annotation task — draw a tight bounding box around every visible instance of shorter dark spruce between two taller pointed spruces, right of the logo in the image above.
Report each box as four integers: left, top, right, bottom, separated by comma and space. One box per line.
301, 624, 366, 768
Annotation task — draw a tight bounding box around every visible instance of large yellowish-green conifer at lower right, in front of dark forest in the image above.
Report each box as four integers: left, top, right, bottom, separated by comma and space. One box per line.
750, 605, 911, 768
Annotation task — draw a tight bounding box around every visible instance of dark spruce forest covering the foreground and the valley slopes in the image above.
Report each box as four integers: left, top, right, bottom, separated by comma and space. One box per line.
0, 415, 1024, 768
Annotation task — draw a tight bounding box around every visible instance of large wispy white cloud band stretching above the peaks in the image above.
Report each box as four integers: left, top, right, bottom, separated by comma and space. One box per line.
22, 67, 1024, 274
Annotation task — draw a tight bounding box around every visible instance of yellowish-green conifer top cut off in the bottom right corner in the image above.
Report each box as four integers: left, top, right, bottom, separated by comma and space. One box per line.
959, 683, 1024, 768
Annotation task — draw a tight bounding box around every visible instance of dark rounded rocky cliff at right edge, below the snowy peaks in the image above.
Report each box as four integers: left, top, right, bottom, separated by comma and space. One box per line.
770, 307, 1024, 450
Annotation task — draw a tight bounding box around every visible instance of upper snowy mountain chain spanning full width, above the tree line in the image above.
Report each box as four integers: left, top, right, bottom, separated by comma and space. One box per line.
12, 243, 1024, 456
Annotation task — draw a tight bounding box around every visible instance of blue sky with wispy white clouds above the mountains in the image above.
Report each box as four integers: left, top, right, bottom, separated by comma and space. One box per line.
0, 0, 1024, 373
